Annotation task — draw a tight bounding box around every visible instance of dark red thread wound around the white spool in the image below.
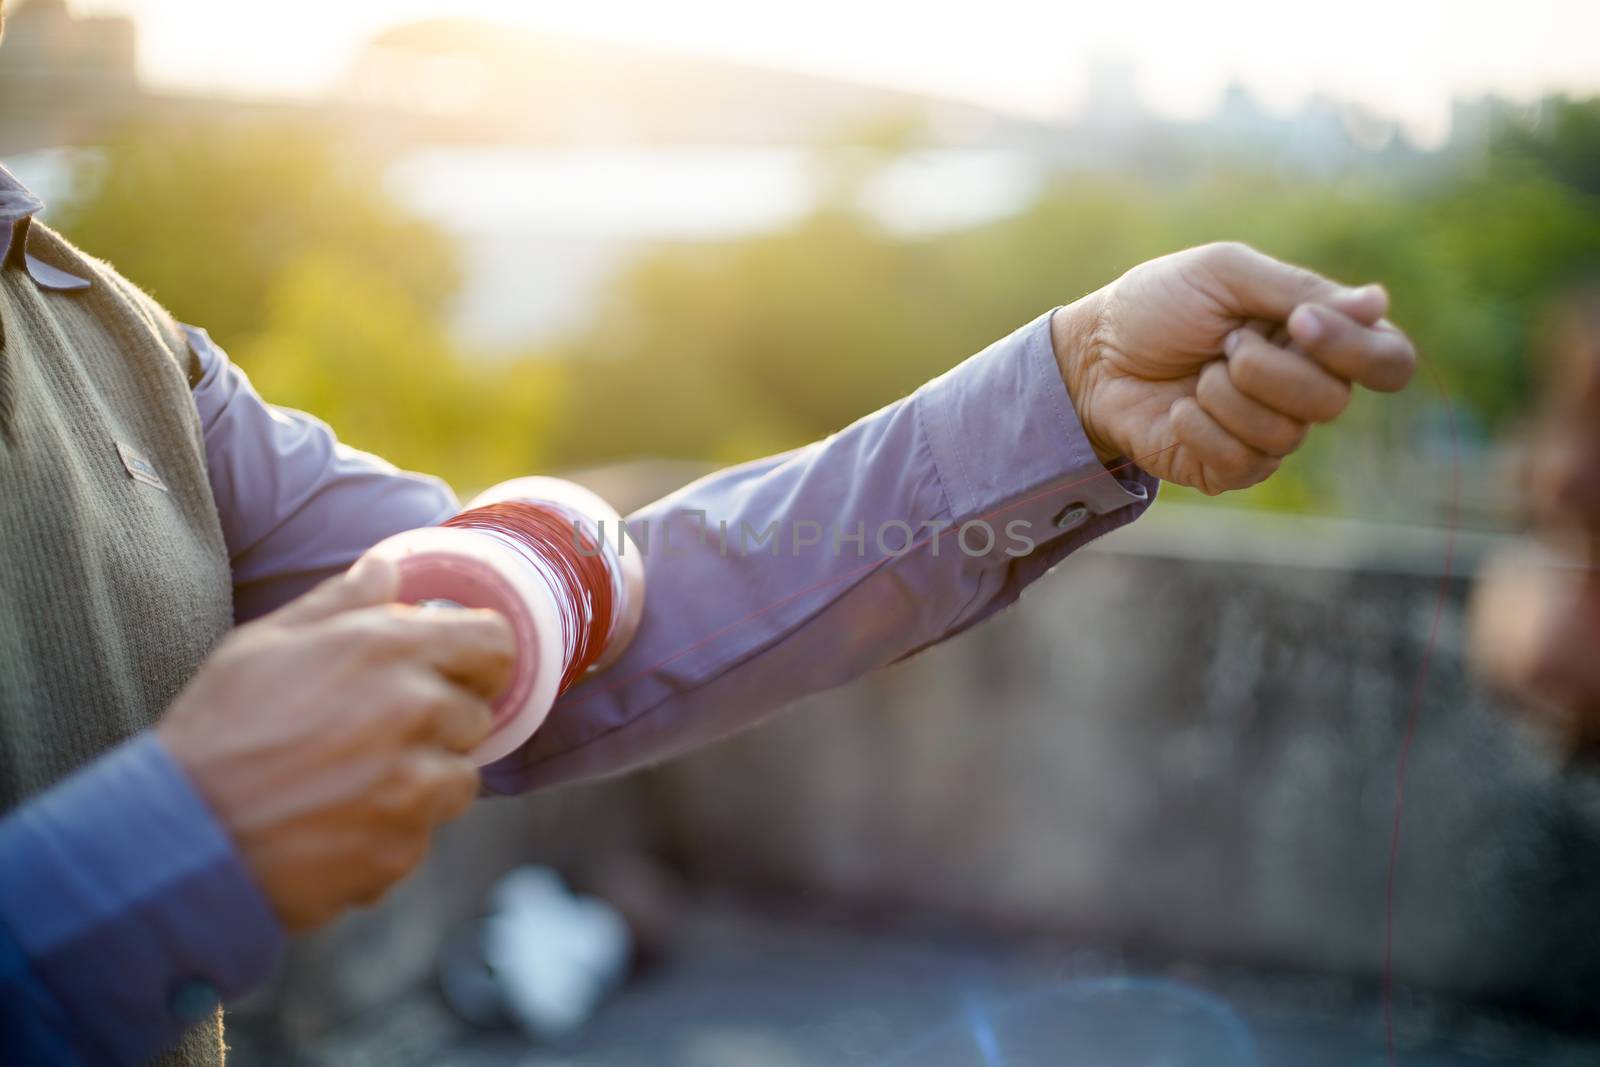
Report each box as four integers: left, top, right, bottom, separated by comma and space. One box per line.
440, 501, 621, 694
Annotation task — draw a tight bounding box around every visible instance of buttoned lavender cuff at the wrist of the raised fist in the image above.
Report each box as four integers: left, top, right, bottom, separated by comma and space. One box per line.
917, 310, 1160, 547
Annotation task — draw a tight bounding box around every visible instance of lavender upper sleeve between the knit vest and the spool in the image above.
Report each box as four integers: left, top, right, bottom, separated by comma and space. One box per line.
184, 326, 458, 622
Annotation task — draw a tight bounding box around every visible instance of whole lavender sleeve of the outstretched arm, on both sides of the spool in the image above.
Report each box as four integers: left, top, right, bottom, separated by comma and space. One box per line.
192, 308, 1157, 792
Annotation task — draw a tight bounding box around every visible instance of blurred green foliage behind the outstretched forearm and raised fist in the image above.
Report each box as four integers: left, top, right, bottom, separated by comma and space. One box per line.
557, 115, 1600, 510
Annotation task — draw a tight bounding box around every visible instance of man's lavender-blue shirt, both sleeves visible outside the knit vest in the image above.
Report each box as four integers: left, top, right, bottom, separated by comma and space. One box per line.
0, 168, 1157, 1064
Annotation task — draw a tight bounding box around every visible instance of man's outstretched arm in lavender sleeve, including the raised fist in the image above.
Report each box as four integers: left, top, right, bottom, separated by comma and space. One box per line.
178, 245, 1414, 792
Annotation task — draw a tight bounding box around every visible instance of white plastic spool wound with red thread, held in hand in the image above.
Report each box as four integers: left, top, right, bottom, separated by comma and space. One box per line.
368, 477, 645, 765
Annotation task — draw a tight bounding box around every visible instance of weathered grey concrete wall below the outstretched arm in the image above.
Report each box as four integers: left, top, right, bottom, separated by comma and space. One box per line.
661, 514, 1600, 1005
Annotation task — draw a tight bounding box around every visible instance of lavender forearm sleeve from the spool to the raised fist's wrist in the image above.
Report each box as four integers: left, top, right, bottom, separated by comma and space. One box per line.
485, 308, 1157, 793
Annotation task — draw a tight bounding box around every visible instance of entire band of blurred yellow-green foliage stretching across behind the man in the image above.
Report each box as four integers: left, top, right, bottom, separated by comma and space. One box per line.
43, 101, 1600, 510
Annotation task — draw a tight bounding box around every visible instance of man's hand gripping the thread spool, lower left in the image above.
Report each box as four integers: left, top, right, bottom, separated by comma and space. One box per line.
155, 560, 514, 931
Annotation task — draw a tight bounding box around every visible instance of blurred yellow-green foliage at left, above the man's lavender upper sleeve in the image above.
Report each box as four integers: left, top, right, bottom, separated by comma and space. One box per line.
51, 125, 566, 488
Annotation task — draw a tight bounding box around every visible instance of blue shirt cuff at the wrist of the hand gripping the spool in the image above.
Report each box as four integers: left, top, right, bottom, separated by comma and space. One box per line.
0, 733, 283, 1064
